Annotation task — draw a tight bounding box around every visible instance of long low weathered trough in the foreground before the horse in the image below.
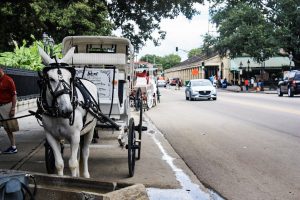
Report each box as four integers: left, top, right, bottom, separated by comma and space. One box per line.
2, 170, 149, 200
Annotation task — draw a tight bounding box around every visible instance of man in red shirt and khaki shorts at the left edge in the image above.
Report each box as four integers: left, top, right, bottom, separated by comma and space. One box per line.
0, 65, 19, 154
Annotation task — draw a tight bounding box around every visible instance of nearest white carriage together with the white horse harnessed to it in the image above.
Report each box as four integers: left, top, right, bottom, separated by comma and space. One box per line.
36, 36, 146, 178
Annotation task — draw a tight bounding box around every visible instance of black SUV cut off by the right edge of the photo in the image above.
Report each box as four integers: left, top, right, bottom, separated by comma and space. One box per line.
277, 70, 300, 97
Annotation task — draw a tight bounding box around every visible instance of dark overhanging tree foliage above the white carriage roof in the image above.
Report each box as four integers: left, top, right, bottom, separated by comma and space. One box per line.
0, 0, 203, 52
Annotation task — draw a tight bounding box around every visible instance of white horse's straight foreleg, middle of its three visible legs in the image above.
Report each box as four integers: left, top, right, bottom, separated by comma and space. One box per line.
69, 130, 80, 177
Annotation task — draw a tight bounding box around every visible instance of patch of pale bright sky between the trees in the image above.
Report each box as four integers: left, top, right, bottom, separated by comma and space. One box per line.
137, 4, 213, 61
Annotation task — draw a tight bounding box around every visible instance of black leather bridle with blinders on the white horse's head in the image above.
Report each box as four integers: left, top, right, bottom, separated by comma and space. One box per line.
38, 66, 78, 125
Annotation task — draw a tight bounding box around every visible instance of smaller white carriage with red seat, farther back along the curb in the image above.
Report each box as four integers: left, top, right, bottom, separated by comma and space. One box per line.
130, 67, 160, 110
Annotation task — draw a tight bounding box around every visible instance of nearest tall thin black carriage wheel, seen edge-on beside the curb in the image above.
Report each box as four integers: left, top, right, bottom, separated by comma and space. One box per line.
127, 118, 136, 177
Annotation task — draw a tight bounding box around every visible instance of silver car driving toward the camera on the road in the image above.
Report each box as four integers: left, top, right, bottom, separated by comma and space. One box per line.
185, 79, 217, 101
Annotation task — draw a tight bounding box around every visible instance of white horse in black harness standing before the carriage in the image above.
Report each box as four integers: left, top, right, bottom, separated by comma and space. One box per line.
39, 48, 97, 178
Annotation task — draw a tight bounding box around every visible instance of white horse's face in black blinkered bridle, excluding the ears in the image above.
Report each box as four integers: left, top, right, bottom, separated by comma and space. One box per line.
43, 66, 75, 118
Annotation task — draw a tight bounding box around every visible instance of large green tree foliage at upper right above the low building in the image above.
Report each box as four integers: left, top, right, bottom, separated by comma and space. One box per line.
206, 0, 300, 63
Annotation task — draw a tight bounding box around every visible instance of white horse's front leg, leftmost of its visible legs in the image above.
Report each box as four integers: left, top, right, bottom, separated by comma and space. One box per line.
46, 134, 64, 176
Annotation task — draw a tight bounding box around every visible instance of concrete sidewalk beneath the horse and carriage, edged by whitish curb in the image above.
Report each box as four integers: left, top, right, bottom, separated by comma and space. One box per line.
0, 104, 216, 199
